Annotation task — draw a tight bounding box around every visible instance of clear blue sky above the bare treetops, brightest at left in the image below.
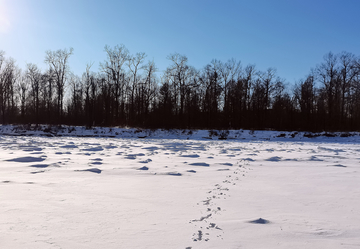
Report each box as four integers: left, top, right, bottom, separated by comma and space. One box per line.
0, 0, 360, 84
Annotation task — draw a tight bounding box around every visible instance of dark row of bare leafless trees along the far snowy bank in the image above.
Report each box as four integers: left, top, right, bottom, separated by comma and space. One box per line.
0, 45, 360, 131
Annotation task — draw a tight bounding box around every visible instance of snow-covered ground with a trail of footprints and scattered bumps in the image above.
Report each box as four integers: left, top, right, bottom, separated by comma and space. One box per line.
0, 126, 360, 249
